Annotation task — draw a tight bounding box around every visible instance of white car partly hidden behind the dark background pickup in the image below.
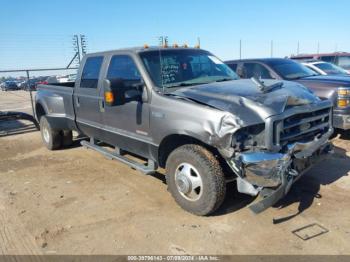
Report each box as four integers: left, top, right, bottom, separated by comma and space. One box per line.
300, 60, 350, 76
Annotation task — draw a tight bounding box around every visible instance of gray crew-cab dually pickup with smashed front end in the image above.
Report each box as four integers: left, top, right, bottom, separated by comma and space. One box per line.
35, 46, 333, 215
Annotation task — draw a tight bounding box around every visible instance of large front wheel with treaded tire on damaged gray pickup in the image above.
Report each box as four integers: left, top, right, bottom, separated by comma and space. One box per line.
166, 145, 226, 216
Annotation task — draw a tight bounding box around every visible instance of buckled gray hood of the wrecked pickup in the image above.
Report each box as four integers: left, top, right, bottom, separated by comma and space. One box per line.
172, 79, 320, 124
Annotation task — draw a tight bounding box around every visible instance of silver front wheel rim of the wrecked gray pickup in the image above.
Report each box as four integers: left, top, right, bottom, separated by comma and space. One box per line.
175, 163, 203, 201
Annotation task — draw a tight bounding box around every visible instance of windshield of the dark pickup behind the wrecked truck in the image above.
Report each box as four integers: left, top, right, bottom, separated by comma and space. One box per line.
271, 60, 318, 80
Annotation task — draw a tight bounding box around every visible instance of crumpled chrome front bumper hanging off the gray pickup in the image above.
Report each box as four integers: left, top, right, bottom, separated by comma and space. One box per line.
227, 128, 333, 213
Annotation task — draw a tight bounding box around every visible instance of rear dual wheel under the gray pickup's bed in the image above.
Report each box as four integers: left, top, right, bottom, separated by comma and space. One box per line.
40, 116, 62, 150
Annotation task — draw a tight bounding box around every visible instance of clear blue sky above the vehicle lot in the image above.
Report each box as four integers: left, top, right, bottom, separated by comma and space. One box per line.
0, 0, 350, 75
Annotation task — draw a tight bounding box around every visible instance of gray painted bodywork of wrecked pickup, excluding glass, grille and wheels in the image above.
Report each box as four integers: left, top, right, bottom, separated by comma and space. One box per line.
36, 48, 330, 156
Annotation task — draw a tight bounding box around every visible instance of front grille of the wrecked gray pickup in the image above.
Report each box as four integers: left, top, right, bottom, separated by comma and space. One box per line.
275, 108, 331, 146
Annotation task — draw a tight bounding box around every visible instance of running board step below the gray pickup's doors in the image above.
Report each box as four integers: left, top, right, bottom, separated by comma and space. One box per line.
80, 139, 157, 174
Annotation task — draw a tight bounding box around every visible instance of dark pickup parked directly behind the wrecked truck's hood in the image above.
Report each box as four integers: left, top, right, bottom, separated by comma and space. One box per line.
226, 58, 350, 130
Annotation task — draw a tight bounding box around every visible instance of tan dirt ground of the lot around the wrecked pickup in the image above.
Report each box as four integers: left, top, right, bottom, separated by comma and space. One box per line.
0, 92, 350, 254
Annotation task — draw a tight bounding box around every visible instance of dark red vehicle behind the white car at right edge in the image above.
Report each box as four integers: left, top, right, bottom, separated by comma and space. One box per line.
291, 52, 350, 73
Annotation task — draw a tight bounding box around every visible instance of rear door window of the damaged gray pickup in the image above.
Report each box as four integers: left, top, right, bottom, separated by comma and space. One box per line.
80, 56, 103, 89
